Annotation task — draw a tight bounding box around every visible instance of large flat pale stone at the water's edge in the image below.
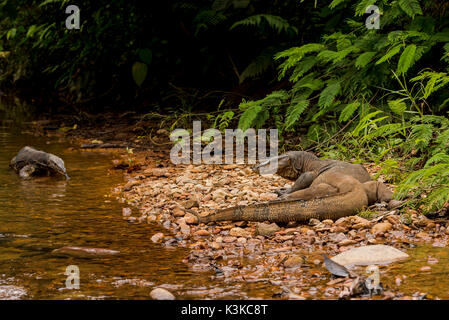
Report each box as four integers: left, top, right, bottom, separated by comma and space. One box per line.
331, 244, 409, 266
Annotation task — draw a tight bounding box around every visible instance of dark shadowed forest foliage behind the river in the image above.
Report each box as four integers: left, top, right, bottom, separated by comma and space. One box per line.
0, 0, 319, 111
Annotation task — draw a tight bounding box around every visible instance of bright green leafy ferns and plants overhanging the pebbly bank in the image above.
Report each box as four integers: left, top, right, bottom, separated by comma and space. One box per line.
234, 0, 449, 211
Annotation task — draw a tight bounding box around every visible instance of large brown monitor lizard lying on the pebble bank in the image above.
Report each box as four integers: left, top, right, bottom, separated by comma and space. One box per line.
192, 152, 392, 223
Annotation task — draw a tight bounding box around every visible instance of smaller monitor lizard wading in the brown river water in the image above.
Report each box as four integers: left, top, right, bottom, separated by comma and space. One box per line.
9, 146, 69, 179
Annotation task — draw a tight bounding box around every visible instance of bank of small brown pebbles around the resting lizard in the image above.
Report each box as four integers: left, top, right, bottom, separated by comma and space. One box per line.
28, 118, 449, 299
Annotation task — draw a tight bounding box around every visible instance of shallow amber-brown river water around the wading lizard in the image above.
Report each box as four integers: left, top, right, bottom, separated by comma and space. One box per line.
0, 124, 220, 299
